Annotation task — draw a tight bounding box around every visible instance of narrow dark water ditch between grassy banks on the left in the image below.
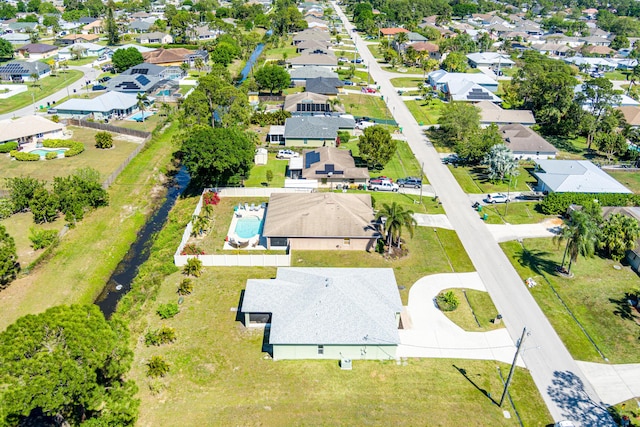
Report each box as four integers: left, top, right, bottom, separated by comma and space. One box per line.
94, 167, 190, 319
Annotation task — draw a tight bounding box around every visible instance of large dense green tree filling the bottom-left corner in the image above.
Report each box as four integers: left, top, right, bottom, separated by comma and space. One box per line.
0, 305, 139, 426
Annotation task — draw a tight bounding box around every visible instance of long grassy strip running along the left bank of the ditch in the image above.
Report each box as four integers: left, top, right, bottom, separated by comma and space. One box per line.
0, 124, 178, 330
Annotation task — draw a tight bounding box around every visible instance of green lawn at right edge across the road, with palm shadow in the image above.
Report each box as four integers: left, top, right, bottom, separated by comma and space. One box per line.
501, 239, 640, 363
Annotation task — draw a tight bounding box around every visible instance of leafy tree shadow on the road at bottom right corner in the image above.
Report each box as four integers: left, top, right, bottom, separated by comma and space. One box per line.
547, 371, 615, 426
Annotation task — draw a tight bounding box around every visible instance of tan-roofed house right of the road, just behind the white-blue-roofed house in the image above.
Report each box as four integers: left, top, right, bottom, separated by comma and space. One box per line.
500, 123, 558, 160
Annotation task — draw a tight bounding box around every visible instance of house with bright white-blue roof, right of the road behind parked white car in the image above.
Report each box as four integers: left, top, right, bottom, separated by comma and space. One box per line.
533, 160, 631, 193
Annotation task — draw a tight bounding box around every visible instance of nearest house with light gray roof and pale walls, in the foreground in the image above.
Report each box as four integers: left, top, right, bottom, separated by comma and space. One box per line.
240, 268, 402, 360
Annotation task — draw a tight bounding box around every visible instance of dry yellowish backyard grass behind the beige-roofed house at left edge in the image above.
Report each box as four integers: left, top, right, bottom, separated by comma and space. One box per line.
0, 127, 139, 187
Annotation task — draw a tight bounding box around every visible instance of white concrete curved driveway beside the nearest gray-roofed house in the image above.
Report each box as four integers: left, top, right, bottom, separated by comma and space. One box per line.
396, 273, 524, 366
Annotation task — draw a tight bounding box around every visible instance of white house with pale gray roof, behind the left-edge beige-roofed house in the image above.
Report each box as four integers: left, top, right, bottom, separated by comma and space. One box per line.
56, 92, 138, 120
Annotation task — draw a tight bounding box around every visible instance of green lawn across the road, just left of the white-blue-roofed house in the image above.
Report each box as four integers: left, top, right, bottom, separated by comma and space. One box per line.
449, 164, 536, 194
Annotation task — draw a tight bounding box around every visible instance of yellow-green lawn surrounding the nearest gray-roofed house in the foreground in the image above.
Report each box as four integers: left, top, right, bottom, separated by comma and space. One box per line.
121, 195, 551, 426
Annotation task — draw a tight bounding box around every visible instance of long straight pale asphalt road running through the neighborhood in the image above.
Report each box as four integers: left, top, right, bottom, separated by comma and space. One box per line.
332, 2, 615, 426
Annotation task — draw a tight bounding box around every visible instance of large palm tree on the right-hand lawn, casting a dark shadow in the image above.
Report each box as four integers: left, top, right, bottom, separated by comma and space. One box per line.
553, 211, 598, 274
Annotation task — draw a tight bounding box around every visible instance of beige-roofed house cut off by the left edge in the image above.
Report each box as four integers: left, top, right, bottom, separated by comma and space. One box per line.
0, 116, 65, 145
